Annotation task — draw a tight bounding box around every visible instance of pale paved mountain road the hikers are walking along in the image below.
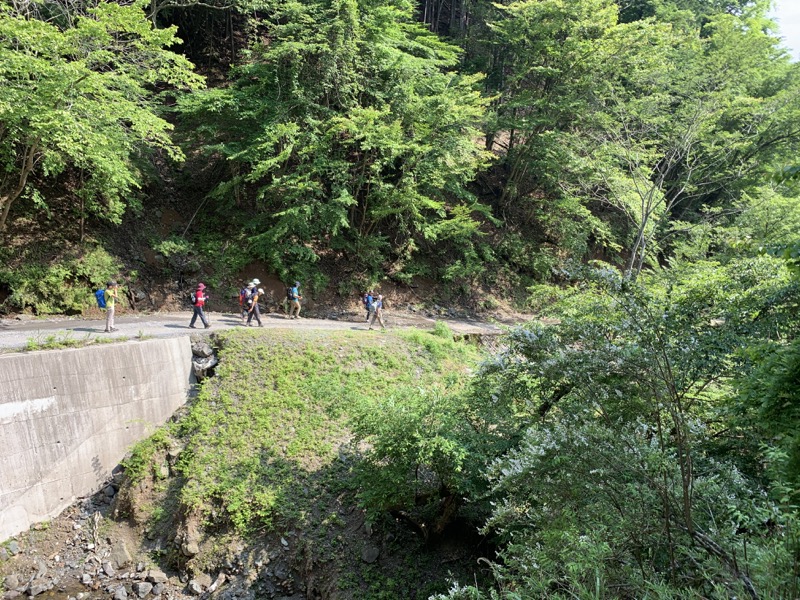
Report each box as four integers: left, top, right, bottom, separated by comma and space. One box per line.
0, 311, 501, 350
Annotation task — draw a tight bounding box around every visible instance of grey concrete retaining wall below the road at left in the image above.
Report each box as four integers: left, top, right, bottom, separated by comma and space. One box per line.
0, 337, 192, 541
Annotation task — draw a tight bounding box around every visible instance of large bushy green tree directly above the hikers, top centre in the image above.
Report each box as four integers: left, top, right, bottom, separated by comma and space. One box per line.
182, 0, 487, 271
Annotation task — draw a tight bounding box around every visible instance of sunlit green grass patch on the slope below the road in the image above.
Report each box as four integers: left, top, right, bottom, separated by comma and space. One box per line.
167, 330, 479, 534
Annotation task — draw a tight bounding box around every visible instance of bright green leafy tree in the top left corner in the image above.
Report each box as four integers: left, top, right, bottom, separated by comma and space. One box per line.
0, 1, 202, 230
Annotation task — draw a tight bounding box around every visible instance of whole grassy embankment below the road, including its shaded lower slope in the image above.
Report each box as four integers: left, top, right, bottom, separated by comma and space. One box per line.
128, 327, 488, 598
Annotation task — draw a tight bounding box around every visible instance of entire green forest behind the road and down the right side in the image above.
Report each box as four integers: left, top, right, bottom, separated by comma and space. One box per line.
0, 0, 800, 598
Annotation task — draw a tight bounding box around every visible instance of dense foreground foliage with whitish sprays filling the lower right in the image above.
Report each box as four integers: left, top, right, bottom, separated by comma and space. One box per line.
432, 257, 798, 598
